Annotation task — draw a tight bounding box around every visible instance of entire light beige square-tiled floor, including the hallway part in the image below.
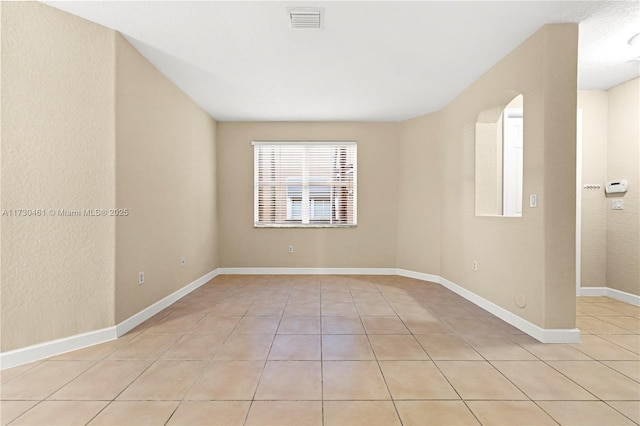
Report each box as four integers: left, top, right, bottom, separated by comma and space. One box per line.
0, 276, 640, 426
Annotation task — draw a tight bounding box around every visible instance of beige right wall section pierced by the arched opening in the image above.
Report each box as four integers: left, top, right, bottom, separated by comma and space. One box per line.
440, 25, 577, 328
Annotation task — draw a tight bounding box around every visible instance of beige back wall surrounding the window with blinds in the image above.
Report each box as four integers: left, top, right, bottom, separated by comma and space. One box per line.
217, 123, 398, 268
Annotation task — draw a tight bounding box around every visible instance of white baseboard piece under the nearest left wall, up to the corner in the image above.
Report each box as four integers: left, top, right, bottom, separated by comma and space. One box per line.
0, 326, 118, 370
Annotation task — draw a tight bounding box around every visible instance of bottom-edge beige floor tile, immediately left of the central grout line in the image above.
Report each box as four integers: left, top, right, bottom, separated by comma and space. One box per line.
245, 401, 322, 426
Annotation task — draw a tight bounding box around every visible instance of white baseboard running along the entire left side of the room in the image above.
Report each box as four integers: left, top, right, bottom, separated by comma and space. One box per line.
0, 269, 219, 370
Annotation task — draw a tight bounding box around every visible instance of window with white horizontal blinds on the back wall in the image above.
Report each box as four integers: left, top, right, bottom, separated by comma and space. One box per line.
252, 142, 357, 227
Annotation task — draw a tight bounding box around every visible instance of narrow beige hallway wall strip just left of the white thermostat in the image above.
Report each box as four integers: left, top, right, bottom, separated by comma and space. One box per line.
578, 90, 608, 287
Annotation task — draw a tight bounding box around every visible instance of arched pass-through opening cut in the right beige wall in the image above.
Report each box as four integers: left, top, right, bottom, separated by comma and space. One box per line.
475, 92, 524, 217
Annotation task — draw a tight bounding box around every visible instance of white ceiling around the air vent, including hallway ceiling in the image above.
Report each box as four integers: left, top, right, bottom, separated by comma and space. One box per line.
44, 1, 640, 121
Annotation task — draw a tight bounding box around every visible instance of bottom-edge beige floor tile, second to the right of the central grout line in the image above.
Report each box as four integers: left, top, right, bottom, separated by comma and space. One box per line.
396, 401, 480, 426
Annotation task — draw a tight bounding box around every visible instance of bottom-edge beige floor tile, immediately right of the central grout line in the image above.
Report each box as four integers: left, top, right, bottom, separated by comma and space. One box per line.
324, 401, 400, 426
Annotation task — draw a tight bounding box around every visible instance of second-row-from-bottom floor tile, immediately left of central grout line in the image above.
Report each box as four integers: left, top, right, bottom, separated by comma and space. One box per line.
254, 361, 322, 400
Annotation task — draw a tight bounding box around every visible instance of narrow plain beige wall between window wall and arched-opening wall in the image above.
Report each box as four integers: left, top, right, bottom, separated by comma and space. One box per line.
396, 113, 446, 275
